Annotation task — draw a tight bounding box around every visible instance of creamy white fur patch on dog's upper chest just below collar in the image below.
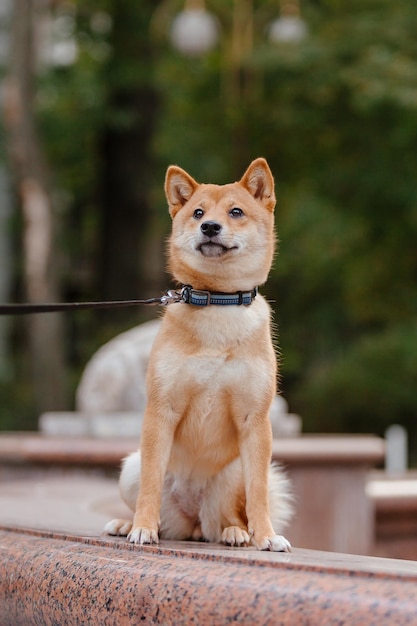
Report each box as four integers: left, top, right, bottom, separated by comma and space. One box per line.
153, 296, 274, 400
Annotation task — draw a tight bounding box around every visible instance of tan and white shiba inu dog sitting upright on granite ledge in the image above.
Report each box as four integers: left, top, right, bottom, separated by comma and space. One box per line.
105, 158, 292, 551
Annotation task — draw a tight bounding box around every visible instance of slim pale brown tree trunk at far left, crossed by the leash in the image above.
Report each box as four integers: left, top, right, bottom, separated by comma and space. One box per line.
5, 0, 67, 412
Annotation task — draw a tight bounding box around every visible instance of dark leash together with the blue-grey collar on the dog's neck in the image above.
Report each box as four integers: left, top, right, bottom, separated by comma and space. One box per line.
0, 285, 258, 315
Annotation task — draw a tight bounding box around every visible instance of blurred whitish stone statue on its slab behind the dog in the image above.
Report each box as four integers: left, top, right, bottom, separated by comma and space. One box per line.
40, 320, 301, 437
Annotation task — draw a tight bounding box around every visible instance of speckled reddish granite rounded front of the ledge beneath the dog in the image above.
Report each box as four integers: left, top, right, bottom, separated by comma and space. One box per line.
0, 527, 417, 626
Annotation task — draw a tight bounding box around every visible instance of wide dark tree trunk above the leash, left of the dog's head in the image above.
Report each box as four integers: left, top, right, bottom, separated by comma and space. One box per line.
100, 0, 161, 299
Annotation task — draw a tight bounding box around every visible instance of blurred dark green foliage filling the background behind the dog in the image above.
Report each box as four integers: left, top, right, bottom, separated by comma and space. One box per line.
0, 0, 417, 458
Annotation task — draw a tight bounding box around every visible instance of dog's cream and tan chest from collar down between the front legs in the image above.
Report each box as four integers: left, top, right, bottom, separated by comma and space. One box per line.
145, 296, 274, 478
